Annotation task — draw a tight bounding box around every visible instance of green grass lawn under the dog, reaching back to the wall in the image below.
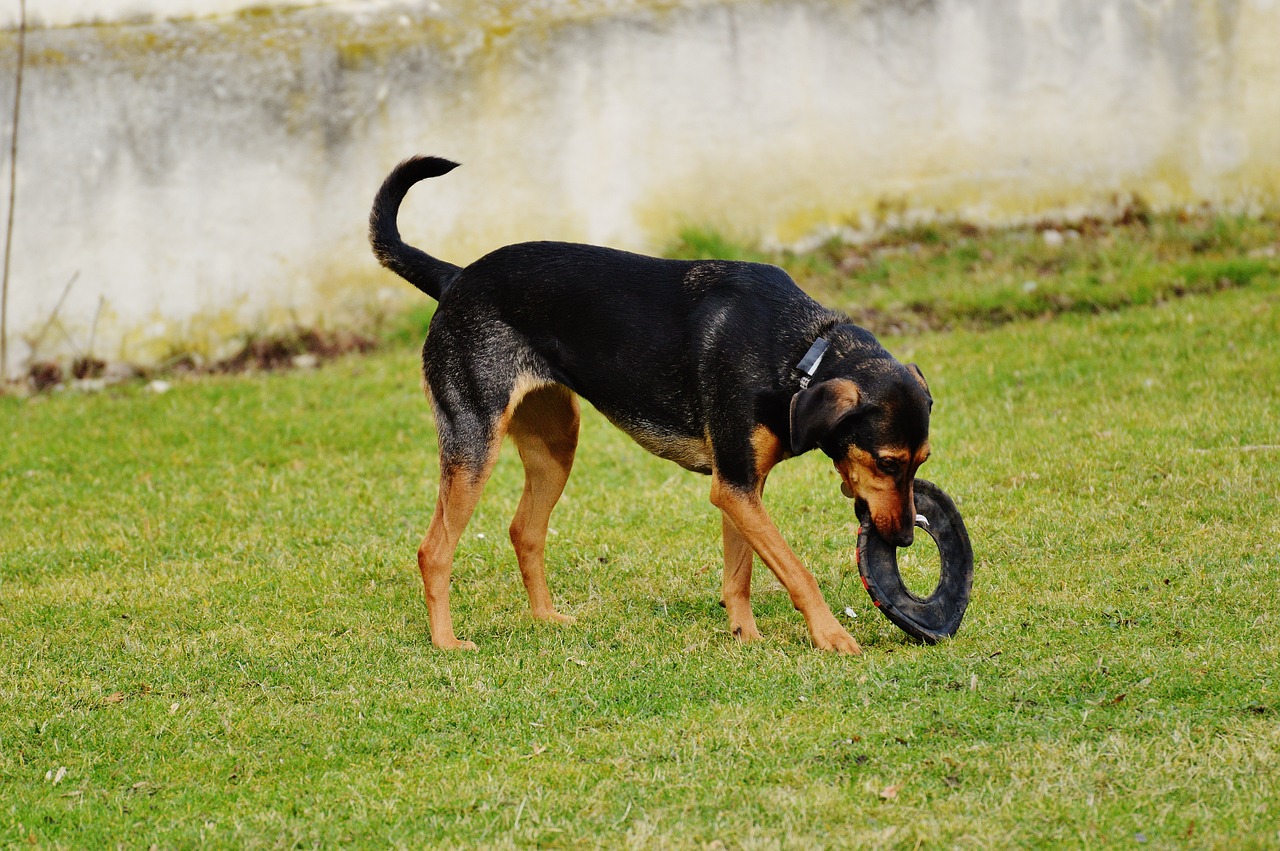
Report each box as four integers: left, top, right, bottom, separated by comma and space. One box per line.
0, 221, 1280, 848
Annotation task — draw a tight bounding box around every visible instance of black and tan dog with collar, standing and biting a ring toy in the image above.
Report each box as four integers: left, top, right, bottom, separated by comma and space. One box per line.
369, 157, 932, 653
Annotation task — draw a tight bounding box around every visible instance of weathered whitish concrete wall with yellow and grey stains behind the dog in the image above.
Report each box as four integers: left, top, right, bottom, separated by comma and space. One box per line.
0, 0, 1280, 373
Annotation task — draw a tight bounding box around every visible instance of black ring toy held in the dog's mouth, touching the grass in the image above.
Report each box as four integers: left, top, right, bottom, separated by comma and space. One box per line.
858, 479, 973, 644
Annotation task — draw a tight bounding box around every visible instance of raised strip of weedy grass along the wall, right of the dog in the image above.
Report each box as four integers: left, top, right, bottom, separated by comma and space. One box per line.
669, 208, 1280, 334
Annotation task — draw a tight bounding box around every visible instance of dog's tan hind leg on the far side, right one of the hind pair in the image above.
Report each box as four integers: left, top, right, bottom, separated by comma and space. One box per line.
508, 384, 580, 623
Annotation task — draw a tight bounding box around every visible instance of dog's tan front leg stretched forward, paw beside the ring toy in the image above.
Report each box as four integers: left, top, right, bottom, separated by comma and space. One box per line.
712, 472, 861, 653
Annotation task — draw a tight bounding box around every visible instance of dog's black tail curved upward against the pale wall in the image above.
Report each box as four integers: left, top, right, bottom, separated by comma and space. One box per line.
369, 156, 462, 301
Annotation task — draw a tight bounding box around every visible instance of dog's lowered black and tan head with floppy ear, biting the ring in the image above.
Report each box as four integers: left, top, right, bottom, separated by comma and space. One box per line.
791, 357, 933, 546
